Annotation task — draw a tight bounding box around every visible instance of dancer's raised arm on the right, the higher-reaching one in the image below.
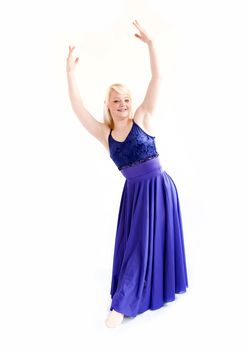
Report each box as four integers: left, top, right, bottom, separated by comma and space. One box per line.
133, 20, 161, 118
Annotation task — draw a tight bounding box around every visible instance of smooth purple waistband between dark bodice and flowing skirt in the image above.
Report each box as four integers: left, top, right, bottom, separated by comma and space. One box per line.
121, 156, 163, 181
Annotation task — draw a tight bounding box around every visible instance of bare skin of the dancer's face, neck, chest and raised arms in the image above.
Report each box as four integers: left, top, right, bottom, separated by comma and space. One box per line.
66, 20, 161, 152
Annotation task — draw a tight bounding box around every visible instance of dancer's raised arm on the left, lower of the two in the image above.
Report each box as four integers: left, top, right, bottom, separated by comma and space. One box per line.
66, 46, 109, 149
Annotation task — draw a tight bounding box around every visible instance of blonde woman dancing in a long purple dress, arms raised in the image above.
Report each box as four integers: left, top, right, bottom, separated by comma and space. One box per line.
67, 20, 188, 327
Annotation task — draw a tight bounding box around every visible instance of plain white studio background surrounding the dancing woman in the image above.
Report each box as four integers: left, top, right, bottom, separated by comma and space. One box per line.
0, 0, 250, 350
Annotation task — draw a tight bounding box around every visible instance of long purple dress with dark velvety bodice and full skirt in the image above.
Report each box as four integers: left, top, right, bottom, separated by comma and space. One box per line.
109, 121, 188, 317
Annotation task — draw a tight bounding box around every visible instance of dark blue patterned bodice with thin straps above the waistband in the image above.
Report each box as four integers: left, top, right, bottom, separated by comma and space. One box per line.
108, 120, 159, 170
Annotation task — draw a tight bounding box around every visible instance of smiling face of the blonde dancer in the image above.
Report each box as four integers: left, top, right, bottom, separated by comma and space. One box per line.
108, 89, 131, 119
